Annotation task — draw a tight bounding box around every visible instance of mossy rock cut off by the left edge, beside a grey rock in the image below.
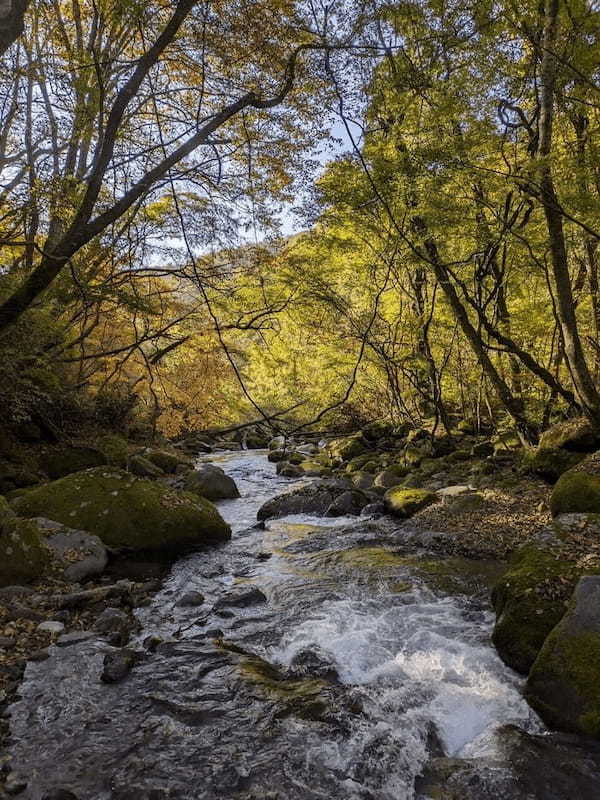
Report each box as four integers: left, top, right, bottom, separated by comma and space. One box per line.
0, 497, 52, 586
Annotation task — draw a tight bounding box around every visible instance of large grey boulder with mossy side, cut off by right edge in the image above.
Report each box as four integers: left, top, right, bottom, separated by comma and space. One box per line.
526, 575, 600, 739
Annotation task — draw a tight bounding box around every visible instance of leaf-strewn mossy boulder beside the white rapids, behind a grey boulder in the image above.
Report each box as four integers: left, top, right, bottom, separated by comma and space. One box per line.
492, 545, 582, 675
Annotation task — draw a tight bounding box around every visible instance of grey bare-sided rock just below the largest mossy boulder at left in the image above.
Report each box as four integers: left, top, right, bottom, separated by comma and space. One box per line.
33, 517, 108, 583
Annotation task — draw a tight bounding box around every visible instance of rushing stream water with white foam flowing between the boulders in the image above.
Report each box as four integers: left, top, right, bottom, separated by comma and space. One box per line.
7, 451, 592, 800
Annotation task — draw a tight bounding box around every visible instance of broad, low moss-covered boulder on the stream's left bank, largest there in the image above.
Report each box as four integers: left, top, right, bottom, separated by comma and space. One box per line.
13, 467, 231, 554
